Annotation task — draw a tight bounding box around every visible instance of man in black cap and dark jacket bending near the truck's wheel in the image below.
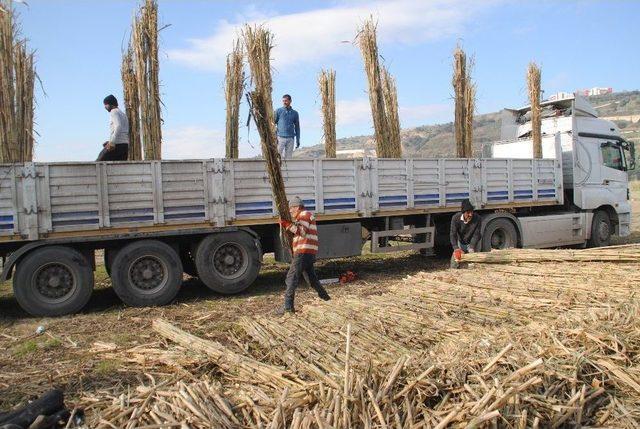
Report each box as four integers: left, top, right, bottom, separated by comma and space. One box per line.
449, 199, 481, 268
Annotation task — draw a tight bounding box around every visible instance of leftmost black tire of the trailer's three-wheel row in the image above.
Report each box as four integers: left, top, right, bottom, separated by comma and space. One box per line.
13, 246, 93, 316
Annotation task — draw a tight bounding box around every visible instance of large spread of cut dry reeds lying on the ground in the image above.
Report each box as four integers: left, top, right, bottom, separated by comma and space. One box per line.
87, 245, 640, 429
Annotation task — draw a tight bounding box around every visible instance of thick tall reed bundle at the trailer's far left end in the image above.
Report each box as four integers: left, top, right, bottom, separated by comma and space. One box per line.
0, 0, 36, 162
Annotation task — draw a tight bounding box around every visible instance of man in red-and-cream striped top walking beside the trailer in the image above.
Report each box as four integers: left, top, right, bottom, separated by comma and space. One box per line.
278, 197, 331, 315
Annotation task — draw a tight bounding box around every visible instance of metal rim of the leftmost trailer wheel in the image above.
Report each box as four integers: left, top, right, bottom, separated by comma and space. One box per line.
31, 262, 78, 304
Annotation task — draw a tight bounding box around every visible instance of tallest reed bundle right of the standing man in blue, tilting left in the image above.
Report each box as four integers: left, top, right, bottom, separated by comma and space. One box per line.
358, 18, 402, 158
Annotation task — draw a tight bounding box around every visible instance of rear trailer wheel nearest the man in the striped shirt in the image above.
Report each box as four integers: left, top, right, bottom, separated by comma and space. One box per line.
195, 231, 261, 294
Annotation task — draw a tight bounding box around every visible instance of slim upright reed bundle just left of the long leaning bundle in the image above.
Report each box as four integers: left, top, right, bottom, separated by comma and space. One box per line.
224, 40, 244, 159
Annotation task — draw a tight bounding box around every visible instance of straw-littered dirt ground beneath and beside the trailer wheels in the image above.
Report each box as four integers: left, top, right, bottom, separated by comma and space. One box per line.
0, 183, 640, 409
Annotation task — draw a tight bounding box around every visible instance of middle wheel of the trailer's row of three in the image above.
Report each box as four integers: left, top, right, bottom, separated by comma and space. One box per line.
111, 240, 182, 307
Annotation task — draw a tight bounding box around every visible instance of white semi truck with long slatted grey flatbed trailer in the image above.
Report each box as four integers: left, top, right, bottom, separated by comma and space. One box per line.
0, 96, 634, 316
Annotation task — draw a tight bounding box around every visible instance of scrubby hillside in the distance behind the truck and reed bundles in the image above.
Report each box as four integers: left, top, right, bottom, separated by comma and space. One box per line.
296, 91, 640, 177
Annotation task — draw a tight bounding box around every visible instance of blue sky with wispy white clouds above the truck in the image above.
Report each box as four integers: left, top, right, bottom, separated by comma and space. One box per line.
16, 0, 640, 161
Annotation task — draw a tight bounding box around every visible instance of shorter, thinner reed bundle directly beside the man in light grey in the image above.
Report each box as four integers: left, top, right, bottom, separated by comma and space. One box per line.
120, 46, 142, 161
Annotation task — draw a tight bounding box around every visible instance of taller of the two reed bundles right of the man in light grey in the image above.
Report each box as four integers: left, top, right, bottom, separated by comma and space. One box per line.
131, 0, 162, 160
